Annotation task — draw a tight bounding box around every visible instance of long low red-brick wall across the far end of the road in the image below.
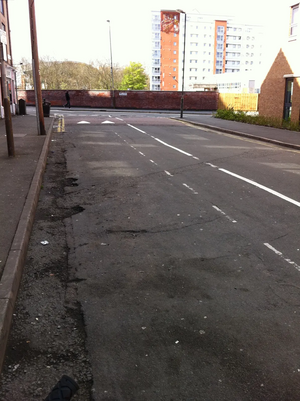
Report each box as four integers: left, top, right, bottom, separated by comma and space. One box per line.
18, 90, 219, 111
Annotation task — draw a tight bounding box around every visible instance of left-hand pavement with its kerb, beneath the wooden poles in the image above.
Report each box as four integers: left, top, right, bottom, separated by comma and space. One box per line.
0, 115, 54, 372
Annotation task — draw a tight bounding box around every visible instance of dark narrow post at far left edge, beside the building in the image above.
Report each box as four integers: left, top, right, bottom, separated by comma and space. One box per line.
0, 38, 15, 157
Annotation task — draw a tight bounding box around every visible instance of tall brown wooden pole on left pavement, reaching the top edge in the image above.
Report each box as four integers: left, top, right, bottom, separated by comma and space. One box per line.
28, 0, 46, 135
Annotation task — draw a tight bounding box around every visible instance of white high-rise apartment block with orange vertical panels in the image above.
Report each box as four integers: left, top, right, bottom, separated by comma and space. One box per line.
150, 10, 263, 90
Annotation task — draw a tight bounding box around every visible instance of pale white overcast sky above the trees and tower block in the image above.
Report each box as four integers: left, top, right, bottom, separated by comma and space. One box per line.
6, 0, 292, 70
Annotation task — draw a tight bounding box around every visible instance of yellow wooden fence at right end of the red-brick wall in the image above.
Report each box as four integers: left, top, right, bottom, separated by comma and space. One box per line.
218, 93, 258, 111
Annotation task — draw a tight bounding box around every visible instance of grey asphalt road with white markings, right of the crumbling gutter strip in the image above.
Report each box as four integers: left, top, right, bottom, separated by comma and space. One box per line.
55, 113, 300, 401
